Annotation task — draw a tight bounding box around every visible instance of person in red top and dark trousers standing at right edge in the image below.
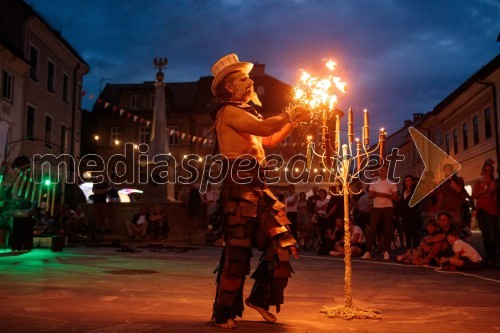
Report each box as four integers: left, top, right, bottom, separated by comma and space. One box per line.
472, 161, 498, 266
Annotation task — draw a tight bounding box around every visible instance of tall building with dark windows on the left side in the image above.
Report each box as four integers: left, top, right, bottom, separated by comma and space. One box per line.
0, 0, 89, 210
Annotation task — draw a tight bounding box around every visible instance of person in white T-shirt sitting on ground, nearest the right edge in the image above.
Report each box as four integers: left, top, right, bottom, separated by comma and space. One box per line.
441, 231, 483, 271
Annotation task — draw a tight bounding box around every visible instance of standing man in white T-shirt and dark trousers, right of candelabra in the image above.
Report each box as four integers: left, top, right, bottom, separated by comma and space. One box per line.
361, 165, 398, 260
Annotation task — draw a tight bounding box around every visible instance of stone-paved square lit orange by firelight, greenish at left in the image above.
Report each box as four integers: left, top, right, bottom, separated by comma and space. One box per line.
0, 241, 500, 333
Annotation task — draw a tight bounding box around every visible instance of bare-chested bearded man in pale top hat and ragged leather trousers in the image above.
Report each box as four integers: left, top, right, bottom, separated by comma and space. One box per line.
211, 54, 308, 328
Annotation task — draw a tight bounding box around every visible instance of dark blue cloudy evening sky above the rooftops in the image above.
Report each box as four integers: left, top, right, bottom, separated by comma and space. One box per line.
27, 0, 500, 134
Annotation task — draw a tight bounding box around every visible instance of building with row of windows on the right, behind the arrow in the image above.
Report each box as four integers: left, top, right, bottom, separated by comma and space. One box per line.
387, 55, 500, 191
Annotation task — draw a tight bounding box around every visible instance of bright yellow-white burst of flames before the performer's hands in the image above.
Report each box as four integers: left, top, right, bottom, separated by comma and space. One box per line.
292, 60, 347, 122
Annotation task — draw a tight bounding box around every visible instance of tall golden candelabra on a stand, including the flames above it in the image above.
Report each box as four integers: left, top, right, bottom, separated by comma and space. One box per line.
292, 61, 380, 319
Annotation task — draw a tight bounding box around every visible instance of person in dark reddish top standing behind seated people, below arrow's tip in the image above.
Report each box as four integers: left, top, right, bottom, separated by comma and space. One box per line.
437, 164, 466, 231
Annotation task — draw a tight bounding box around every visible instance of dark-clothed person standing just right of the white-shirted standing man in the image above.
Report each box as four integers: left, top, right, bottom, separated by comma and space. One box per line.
398, 175, 421, 252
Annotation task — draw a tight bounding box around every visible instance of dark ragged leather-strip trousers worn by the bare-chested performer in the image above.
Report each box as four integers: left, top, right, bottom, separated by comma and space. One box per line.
213, 104, 296, 323
